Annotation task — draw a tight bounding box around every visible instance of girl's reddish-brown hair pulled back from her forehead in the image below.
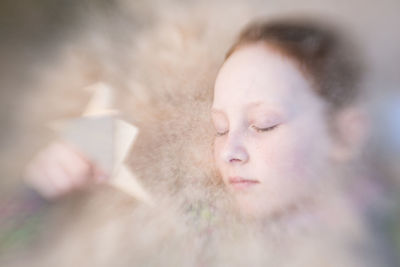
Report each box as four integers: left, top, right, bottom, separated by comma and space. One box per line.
225, 19, 361, 110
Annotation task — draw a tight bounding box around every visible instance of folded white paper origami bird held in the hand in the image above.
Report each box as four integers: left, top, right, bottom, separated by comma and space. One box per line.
51, 83, 152, 204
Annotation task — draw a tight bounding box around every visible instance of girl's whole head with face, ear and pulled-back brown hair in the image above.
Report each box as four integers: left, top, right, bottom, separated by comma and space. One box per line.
212, 18, 365, 220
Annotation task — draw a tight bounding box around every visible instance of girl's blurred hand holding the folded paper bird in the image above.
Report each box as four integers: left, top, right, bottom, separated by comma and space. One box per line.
24, 143, 107, 199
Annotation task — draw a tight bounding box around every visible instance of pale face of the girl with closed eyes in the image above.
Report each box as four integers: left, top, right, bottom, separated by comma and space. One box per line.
212, 43, 332, 216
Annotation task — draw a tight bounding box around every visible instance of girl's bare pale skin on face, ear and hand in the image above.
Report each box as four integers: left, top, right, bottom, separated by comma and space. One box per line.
24, 43, 365, 211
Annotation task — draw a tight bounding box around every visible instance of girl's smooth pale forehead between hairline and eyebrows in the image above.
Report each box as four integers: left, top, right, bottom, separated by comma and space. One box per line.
214, 43, 313, 113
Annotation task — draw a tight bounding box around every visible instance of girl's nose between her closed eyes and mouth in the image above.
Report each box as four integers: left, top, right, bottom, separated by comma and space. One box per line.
222, 133, 249, 164
